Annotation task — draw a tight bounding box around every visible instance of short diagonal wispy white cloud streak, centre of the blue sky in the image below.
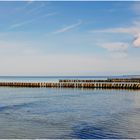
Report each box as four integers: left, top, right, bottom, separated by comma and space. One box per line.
53, 21, 82, 34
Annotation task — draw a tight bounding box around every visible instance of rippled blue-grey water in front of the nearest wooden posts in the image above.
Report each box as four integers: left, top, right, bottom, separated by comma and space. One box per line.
0, 87, 140, 139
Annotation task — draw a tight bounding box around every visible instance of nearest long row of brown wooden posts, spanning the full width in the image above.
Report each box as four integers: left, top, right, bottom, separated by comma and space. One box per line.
0, 82, 140, 89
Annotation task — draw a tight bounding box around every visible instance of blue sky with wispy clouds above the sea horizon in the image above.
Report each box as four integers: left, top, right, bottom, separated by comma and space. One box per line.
0, 1, 140, 76
